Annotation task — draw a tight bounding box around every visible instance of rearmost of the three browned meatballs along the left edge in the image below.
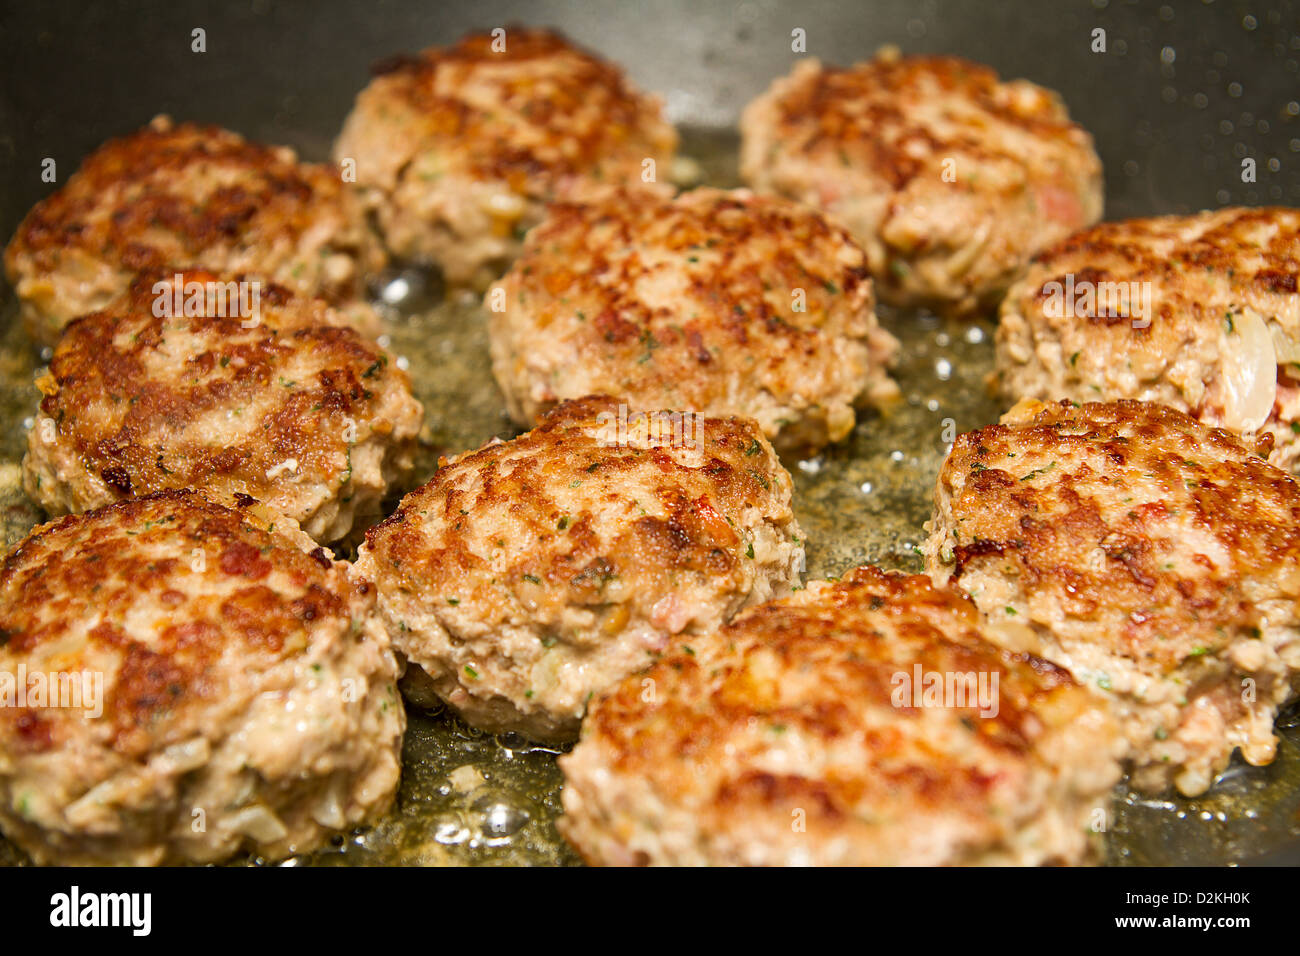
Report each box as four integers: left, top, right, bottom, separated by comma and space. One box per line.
4, 116, 385, 345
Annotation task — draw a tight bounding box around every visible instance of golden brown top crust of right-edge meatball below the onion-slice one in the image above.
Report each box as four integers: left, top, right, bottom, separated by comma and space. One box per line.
941, 402, 1300, 670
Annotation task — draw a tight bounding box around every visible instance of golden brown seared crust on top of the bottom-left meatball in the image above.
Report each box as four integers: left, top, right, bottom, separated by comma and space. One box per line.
0, 489, 359, 757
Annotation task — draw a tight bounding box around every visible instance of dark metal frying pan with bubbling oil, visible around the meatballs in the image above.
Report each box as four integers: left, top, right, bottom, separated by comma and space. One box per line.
0, 0, 1300, 865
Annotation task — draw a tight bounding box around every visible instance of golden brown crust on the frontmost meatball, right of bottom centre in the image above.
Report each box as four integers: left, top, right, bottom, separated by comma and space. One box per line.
590, 567, 1074, 770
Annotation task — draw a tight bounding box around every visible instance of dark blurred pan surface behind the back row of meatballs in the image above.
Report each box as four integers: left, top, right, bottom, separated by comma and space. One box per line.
0, 0, 1300, 254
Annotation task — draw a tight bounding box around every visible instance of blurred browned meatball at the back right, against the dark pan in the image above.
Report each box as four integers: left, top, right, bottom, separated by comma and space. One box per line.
740, 48, 1102, 313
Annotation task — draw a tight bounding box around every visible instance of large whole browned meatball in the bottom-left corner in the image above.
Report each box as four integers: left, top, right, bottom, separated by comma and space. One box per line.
0, 489, 406, 865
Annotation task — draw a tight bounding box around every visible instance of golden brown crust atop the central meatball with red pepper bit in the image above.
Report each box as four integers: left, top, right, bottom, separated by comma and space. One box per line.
365, 395, 790, 604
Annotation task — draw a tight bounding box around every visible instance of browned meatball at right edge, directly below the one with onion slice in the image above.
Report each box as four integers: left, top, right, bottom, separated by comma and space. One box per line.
923, 401, 1300, 796
